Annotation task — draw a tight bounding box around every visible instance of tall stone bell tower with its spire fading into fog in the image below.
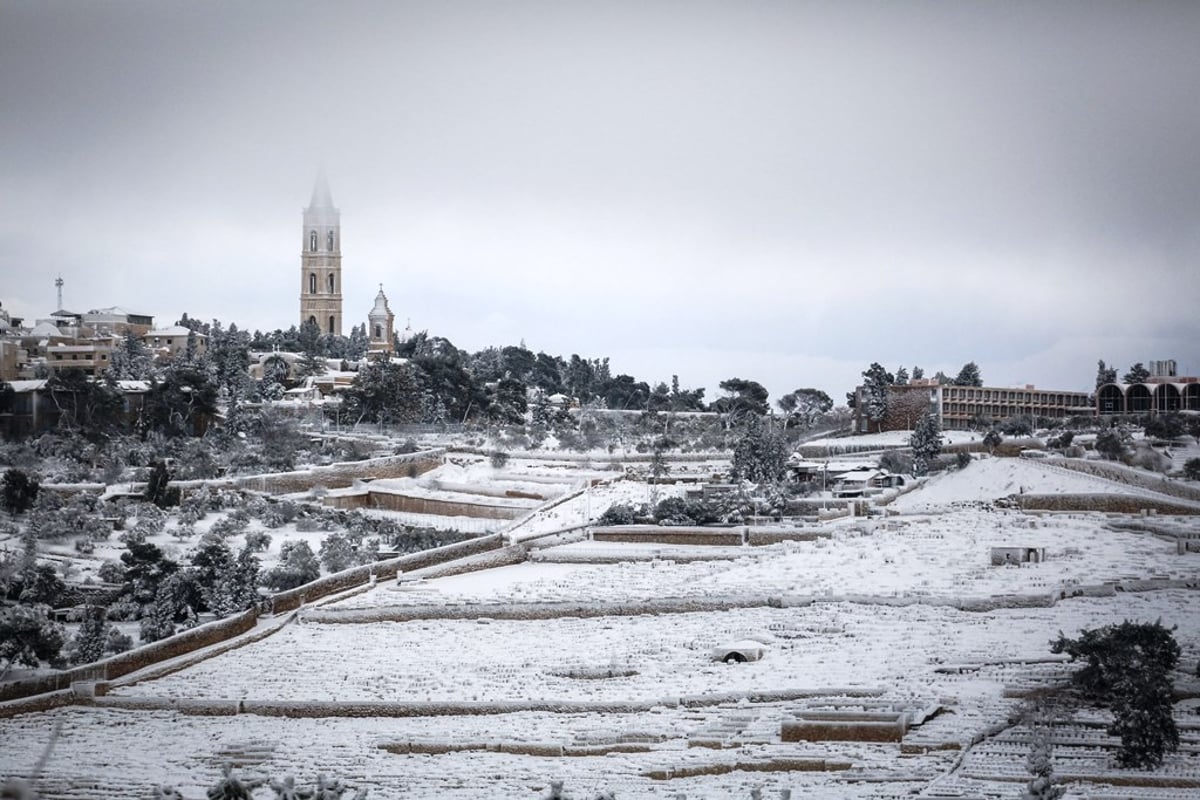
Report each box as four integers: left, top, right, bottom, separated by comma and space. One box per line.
300, 169, 342, 336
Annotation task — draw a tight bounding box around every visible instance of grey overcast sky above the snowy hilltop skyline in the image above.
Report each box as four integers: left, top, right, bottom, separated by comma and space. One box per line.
0, 0, 1200, 401
